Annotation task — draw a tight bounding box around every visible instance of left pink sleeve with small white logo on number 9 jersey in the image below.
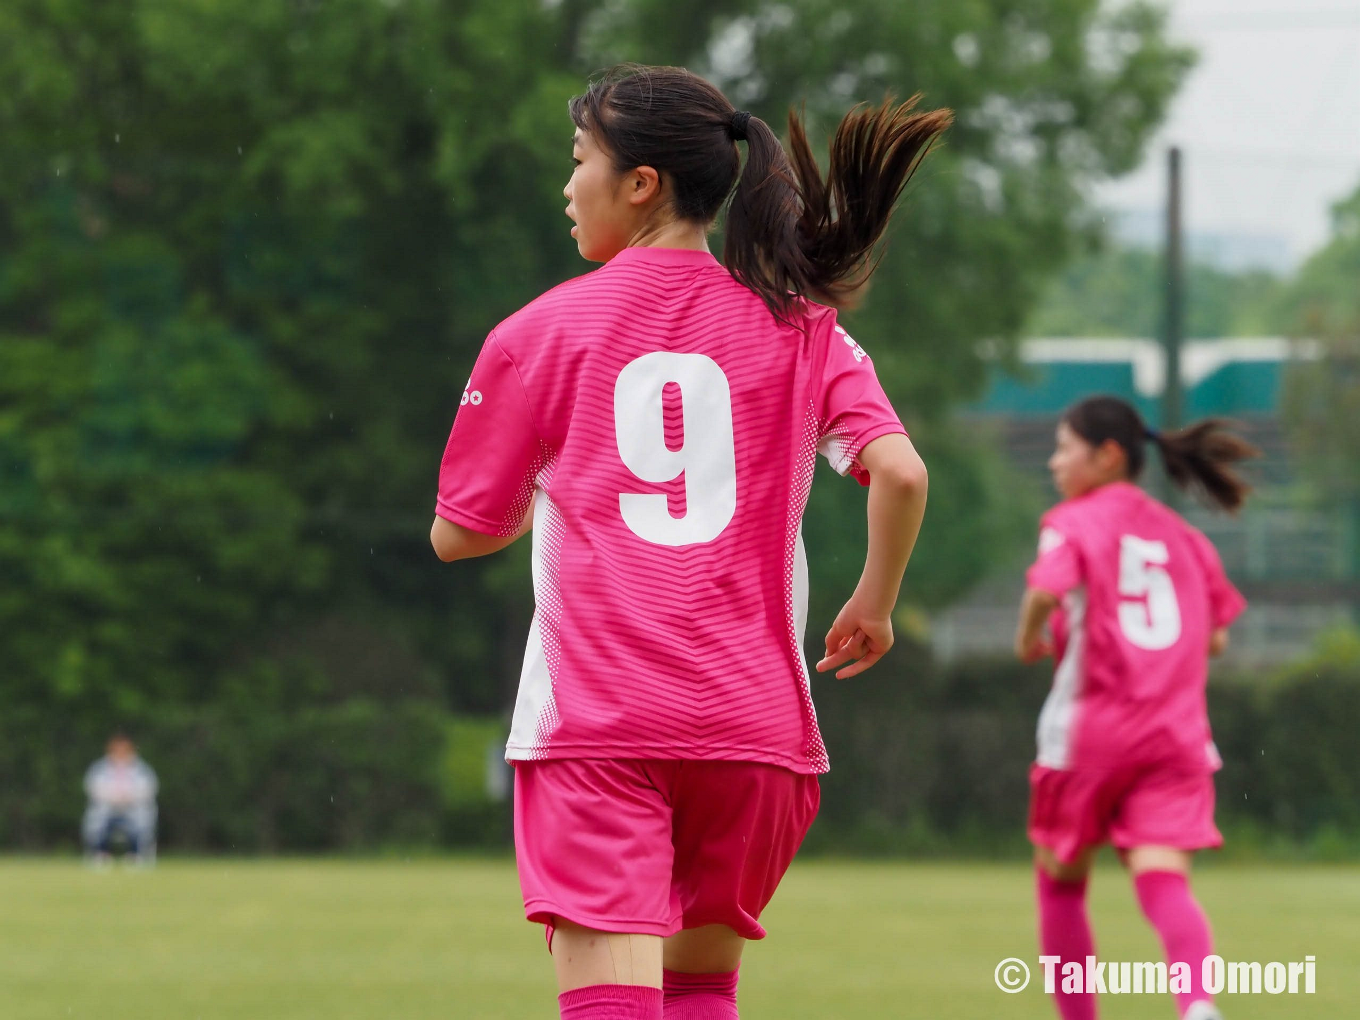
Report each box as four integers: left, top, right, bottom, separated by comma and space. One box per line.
435, 333, 543, 536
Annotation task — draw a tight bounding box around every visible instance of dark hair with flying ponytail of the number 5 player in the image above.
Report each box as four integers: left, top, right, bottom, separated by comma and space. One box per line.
1062, 397, 1261, 510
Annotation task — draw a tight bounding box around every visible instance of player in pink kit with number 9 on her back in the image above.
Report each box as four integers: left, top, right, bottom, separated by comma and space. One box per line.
431, 67, 949, 1020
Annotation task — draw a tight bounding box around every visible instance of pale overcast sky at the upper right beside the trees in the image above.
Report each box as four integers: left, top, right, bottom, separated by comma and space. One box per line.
1099, 0, 1360, 262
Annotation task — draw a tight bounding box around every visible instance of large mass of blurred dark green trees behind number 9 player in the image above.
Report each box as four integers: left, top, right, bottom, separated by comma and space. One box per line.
0, 0, 1190, 718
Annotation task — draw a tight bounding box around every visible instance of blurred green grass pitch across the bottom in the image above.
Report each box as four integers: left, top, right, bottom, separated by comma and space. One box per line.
0, 860, 1360, 1020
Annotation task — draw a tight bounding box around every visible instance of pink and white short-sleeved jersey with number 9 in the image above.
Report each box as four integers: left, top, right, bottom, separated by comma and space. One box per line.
437, 248, 903, 772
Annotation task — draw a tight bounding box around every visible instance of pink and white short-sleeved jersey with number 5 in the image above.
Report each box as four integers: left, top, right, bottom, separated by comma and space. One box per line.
1027, 483, 1246, 771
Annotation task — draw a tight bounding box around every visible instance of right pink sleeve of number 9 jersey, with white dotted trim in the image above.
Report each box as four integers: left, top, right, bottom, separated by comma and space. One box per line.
813, 313, 907, 486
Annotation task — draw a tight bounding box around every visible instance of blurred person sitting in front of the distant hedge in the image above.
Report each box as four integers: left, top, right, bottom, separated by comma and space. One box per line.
80, 733, 158, 864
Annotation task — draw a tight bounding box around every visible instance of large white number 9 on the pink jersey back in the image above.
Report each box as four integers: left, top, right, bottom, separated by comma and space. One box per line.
613, 351, 737, 545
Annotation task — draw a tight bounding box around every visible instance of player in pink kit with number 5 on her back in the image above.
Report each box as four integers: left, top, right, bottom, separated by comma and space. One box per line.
1016, 397, 1255, 1020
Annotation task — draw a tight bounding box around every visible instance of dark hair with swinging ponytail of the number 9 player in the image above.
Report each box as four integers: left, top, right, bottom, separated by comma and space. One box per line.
570, 64, 953, 317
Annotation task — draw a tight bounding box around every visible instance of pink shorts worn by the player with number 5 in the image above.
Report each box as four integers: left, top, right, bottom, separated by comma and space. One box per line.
1030, 764, 1223, 864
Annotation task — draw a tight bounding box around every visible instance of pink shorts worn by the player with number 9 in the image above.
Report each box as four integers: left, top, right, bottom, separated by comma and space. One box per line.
514, 759, 821, 942
